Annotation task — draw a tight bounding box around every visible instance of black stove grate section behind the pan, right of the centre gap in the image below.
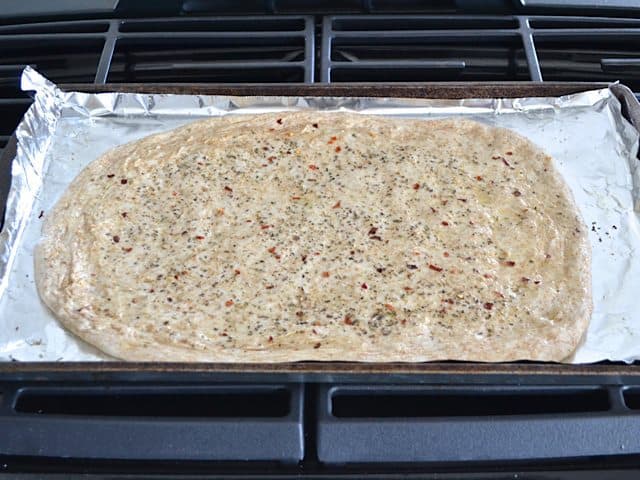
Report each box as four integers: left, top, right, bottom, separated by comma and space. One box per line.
321, 15, 640, 84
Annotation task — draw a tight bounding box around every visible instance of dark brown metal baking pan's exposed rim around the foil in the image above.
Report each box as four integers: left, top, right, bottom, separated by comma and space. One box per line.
0, 82, 640, 385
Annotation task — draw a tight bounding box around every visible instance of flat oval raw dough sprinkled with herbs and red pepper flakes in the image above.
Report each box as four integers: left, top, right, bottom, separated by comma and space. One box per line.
36, 112, 592, 362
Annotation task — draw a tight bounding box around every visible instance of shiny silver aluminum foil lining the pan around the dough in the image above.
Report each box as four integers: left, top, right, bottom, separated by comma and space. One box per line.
0, 67, 640, 363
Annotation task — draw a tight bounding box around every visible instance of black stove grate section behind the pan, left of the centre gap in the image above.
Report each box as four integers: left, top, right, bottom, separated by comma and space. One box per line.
0, 16, 315, 151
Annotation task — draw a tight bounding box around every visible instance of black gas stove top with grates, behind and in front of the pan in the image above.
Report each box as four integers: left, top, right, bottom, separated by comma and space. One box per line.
0, 0, 640, 479
